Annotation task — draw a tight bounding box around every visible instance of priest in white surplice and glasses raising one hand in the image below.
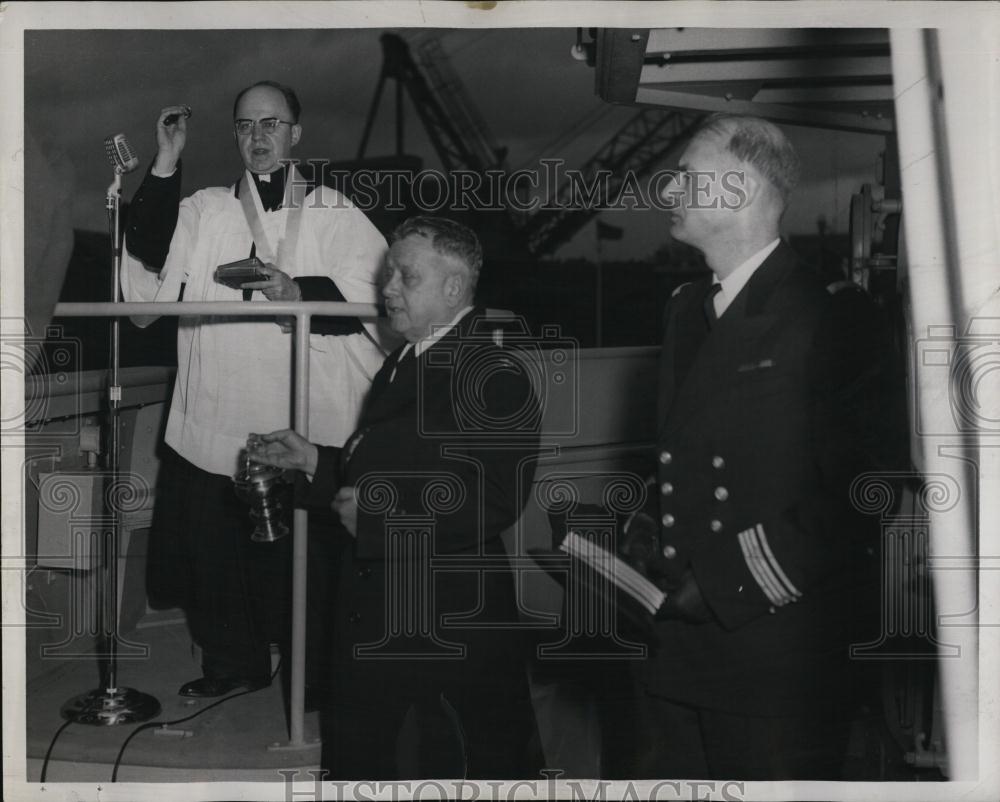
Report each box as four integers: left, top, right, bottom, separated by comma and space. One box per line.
122, 82, 388, 697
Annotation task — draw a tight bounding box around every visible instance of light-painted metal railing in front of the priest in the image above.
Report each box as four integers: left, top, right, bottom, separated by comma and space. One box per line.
55, 301, 378, 749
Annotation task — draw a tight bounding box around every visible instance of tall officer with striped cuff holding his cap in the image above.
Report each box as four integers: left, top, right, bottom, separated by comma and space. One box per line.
629, 115, 896, 780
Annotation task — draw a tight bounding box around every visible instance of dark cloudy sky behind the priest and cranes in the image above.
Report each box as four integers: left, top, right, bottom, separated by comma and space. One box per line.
25, 26, 881, 259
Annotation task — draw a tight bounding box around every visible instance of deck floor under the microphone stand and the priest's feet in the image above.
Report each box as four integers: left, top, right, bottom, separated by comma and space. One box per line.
26, 621, 319, 782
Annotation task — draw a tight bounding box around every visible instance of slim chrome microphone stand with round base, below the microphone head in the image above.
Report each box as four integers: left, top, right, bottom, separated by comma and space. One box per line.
61, 163, 160, 726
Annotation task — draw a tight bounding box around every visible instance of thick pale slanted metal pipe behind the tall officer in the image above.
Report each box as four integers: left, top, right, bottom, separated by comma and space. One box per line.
890, 29, 979, 780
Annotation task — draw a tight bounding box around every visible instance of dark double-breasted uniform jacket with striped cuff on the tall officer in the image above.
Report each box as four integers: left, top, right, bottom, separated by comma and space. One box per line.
641, 244, 884, 715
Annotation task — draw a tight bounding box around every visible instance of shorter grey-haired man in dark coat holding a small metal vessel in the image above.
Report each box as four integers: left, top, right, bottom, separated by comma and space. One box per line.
251, 217, 540, 780
